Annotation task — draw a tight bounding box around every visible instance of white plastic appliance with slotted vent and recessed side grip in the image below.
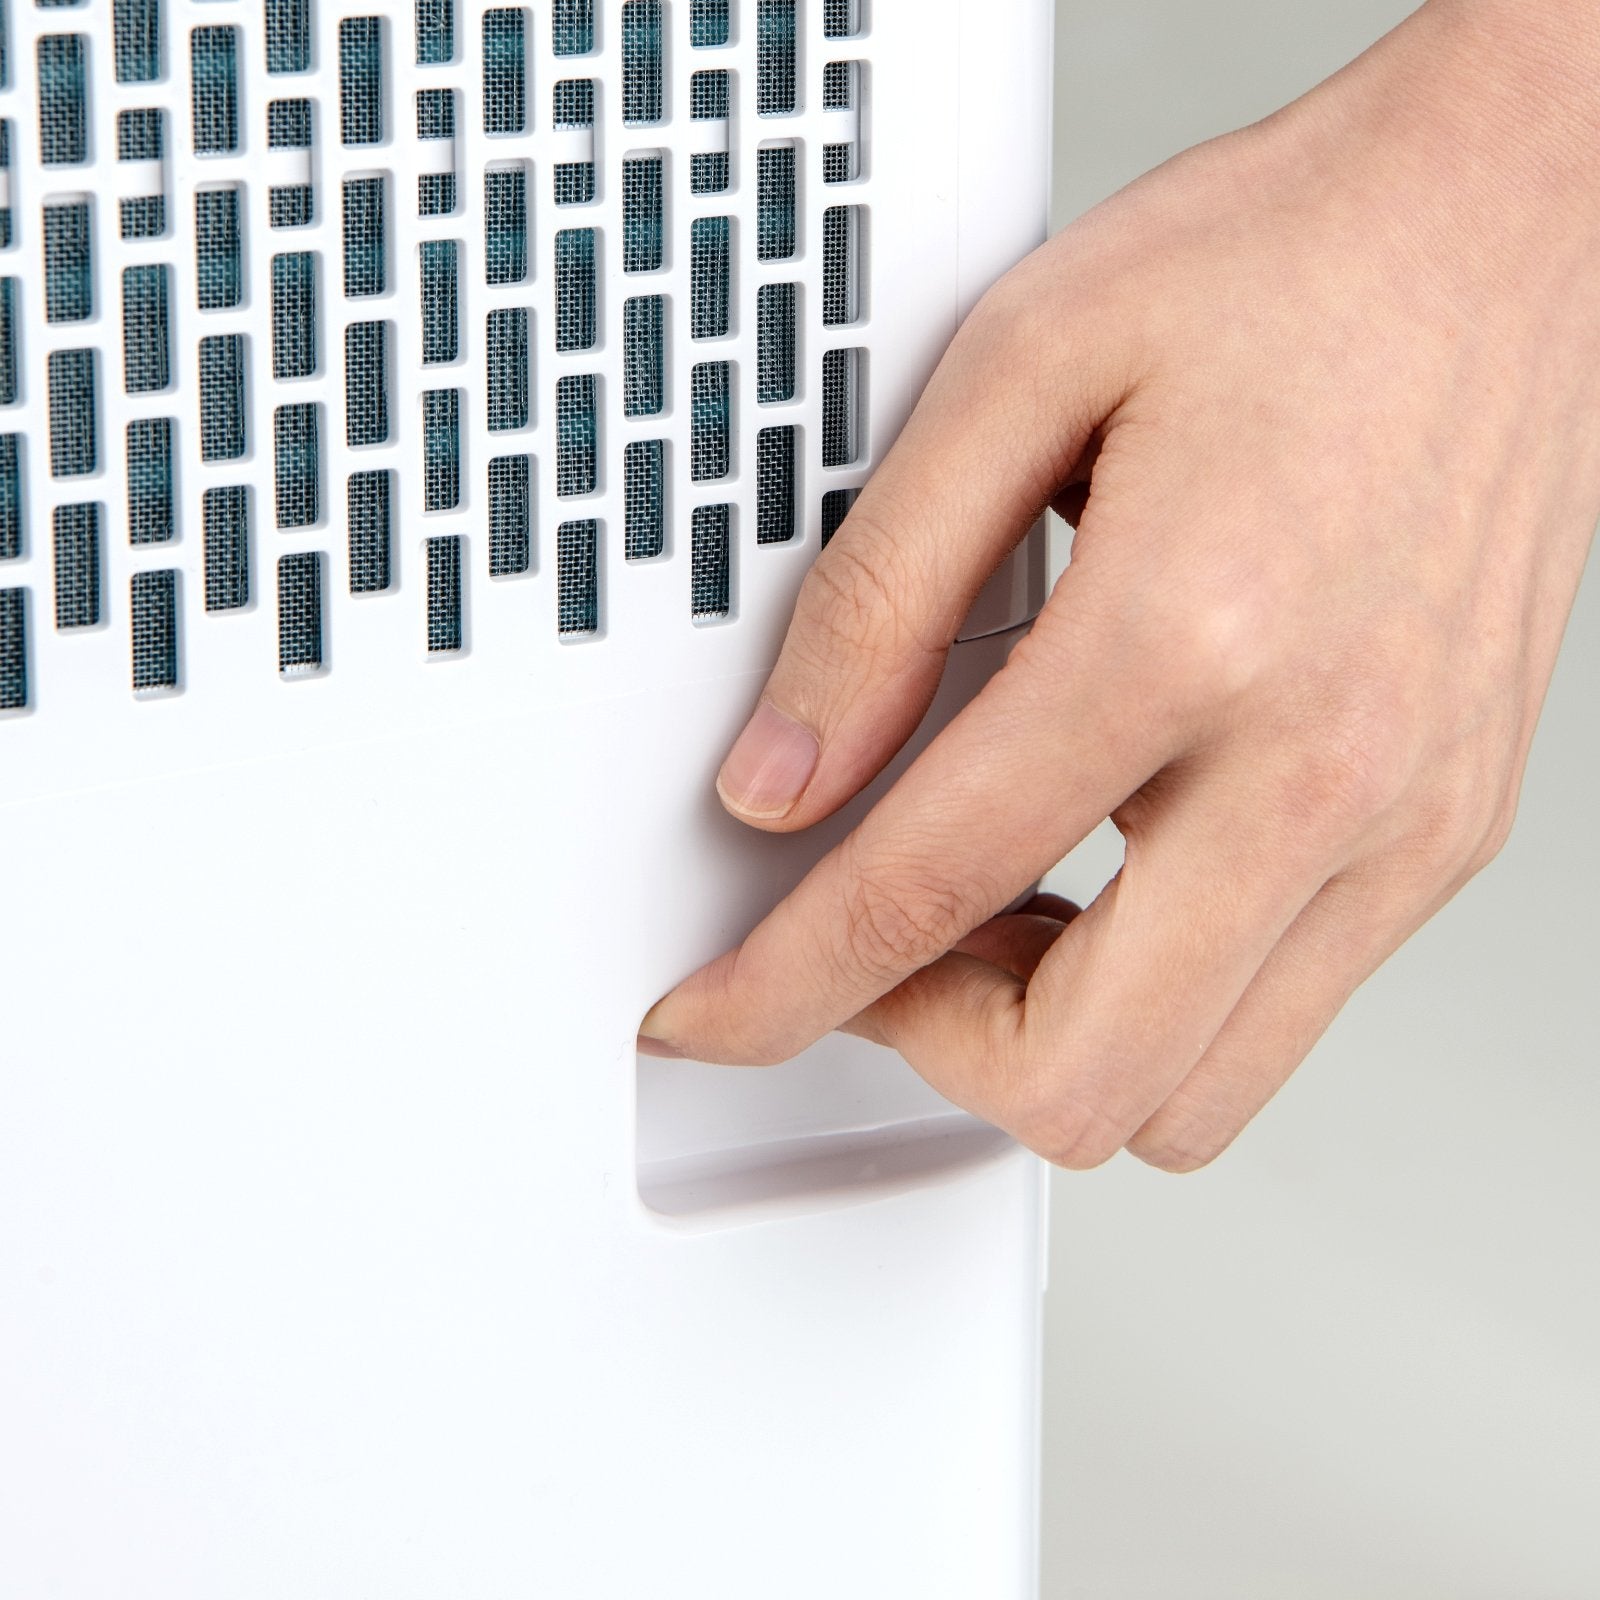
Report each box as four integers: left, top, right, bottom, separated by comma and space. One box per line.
0, 0, 1050, 1600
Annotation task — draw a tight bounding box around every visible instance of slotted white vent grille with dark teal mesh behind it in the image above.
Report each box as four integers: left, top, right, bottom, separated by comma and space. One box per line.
0, 0, 883, 715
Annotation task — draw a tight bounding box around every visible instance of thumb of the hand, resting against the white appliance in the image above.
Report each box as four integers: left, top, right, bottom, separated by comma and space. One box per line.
717, 259, 1130, 832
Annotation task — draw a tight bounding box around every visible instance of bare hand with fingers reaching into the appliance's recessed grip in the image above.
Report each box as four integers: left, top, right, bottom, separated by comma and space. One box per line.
640, 0, 1600, 1171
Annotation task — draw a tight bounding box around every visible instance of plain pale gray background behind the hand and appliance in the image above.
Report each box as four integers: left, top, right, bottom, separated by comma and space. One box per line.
1043, 0, 1600, 1600
